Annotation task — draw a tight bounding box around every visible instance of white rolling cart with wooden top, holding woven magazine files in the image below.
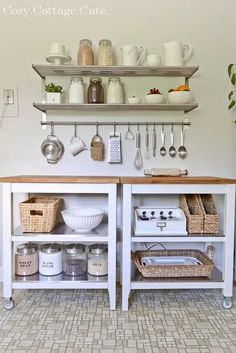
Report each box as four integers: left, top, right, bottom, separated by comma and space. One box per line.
121, 176, 236, 311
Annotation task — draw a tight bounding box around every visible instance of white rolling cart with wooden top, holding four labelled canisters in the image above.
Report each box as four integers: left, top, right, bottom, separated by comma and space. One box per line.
0, 176, 119, 310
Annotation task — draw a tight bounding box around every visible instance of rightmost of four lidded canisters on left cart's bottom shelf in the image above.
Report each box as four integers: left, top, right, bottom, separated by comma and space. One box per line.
88, 244, 108, 276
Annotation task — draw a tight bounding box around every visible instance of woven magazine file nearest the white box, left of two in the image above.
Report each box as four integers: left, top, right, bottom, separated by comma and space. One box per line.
179, 194, 203, 235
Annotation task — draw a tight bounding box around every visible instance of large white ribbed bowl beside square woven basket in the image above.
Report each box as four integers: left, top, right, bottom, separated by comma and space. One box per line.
61, 208, 104, 233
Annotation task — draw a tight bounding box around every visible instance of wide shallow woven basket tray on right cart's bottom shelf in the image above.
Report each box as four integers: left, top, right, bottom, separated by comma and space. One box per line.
132, 250, 215, 278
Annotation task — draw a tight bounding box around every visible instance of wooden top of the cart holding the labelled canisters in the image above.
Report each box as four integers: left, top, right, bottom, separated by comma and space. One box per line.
0, 175, 120, 184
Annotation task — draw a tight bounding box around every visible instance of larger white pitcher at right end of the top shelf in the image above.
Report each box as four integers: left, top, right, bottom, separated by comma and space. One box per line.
164, 41, 192, 66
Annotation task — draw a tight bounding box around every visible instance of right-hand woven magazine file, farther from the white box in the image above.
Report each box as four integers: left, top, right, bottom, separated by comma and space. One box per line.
198, 194, 219, 235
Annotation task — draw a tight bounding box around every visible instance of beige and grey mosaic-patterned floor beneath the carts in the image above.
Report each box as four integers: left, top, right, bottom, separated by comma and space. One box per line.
0, 290, 236, 353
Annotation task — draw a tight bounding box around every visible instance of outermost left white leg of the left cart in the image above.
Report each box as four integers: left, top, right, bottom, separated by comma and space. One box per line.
2, 183, 14, 307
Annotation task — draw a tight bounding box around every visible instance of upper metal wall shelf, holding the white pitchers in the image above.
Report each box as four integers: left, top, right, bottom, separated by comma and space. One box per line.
32, 65, 199, 79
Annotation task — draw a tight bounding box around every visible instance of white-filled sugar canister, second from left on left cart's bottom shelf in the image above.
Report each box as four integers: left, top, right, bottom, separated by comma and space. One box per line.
39, 243, 62, 276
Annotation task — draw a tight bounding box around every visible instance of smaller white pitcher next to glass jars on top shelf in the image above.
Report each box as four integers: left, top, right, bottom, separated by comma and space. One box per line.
121, 44, 146, 66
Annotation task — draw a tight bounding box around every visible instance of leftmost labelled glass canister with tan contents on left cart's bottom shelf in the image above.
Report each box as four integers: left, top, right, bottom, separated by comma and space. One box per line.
15, 243, 39, 276
